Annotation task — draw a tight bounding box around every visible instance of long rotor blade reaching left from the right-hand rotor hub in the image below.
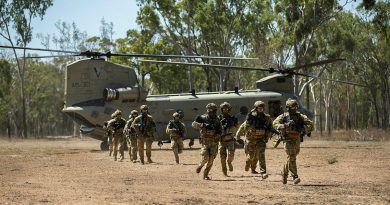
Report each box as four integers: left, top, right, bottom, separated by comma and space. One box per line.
138, 60, 272, 73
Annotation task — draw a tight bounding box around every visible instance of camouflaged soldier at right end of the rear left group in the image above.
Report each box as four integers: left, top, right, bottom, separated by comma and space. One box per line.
131, 105, 157, 164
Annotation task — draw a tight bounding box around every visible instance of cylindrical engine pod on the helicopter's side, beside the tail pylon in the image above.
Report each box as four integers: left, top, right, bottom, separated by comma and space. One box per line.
103, 86, 148, 102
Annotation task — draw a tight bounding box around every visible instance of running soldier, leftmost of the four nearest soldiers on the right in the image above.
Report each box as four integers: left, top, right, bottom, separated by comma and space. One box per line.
192, 103, 222, 180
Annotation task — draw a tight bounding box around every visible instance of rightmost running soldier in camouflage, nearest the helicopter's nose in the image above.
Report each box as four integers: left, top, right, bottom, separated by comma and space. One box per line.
273, 98, 313, 184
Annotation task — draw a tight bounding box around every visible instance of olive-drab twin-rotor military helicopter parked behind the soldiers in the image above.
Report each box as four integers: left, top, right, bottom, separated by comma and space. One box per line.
0, 46, 359, 150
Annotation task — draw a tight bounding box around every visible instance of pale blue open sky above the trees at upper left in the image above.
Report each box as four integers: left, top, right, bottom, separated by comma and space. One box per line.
28, 0, 138, 48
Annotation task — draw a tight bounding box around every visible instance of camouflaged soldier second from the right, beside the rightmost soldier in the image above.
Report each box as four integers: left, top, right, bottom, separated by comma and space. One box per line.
237, 101, 272, 179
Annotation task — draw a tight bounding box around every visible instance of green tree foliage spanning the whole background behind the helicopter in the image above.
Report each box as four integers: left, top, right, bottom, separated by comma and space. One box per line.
0, 0, 390, 138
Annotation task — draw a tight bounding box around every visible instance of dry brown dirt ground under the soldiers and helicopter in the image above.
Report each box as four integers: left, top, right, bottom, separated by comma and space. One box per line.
0, 138, 390, 204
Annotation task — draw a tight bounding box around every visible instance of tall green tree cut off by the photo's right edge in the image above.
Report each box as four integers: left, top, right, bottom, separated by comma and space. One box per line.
353, 1, 390, 129
